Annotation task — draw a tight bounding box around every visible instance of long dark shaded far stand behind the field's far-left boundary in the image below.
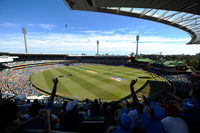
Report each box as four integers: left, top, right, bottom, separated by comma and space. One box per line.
0, 53, 128, 65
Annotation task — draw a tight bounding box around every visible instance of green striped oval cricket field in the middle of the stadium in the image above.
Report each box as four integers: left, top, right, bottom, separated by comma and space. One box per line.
30, 65, 164, 100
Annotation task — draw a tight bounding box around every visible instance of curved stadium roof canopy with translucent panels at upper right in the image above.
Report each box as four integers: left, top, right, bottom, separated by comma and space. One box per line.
64, 0, 200, 44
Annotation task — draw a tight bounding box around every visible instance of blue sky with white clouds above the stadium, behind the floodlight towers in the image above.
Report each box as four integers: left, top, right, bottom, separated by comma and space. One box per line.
0, 0, 200, 55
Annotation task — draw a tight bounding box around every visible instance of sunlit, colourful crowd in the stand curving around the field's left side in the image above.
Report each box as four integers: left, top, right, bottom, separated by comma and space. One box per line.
0, 64, 63, 97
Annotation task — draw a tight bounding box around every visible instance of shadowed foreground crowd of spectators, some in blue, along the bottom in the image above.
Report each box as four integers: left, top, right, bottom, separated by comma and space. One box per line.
0, 78, 200, 133
